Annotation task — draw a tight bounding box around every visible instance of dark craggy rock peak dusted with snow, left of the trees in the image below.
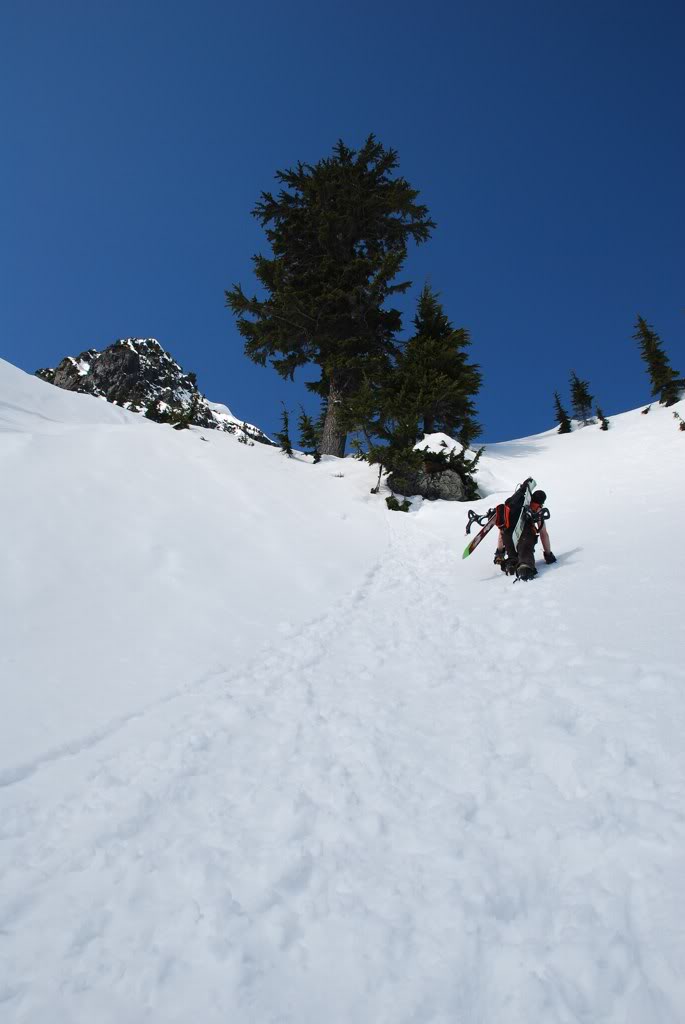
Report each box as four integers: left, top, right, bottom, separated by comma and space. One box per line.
36, 338, 271, 444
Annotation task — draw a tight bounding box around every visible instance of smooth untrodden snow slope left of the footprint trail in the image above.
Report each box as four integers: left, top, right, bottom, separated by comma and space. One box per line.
0, 360, 382, 770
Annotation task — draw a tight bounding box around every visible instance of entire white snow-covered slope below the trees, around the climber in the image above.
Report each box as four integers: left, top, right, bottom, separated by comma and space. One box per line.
0, 361, 685, 1024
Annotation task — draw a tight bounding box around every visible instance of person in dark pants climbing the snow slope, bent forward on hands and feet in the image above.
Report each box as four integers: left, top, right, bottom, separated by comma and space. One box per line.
495, 480, 556, 581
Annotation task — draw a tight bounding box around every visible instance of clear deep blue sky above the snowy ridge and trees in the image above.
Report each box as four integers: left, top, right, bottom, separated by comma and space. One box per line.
0, 0, 685, 440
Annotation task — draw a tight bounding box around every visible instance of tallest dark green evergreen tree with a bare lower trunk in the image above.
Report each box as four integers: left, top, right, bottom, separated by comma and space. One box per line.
225, 135, 435, 456
